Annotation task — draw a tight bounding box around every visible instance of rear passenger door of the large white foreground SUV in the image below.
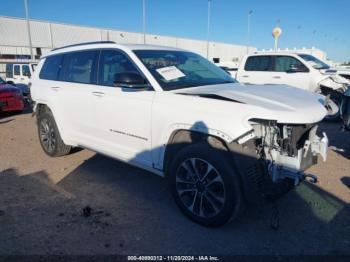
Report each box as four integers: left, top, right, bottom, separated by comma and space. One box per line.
56, 50, 99, 147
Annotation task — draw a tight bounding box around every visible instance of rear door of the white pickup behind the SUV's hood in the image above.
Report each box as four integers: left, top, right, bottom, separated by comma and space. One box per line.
237, 55, 273, 84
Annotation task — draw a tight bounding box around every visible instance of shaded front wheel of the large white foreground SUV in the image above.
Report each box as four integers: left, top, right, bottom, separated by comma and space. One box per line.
168, 143, 242, 227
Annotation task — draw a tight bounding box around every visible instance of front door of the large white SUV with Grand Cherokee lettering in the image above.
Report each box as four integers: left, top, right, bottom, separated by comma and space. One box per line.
91, 49, 154, 167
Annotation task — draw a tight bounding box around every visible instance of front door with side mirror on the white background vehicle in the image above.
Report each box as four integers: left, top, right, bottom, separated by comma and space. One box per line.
271, 55, 311, 90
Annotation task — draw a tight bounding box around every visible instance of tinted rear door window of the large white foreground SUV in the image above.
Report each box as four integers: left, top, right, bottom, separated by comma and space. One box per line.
60, 51, 97, 84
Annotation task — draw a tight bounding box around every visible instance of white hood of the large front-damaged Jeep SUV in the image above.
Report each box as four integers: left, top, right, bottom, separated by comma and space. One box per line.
174, 83, 327, 123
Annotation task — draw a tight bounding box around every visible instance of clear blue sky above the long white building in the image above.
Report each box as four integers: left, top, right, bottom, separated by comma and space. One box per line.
0, 0, 350, 62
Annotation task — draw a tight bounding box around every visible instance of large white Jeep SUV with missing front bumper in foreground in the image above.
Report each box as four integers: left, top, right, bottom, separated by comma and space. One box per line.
32, 42, 328, 226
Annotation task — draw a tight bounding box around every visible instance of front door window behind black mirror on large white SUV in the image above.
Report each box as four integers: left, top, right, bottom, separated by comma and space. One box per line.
98, 50, 138, 86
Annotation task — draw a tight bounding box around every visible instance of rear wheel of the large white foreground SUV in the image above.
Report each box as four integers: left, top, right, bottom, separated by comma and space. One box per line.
38, 111, 72, 157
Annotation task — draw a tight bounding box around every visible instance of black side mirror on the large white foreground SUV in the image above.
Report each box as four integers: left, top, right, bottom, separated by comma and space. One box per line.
113, 73, 150, 90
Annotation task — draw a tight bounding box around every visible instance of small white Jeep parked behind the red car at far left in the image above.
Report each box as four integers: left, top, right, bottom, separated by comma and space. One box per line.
6, 63, 37, 85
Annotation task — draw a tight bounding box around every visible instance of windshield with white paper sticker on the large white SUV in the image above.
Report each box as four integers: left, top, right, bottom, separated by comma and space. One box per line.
134, 50, 235, 90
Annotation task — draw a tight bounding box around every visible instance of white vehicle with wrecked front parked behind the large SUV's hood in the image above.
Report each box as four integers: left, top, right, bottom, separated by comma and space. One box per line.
236, 52, 350, 121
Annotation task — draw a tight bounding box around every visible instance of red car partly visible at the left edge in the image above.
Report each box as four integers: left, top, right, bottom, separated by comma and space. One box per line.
0, 77, 24, 112
